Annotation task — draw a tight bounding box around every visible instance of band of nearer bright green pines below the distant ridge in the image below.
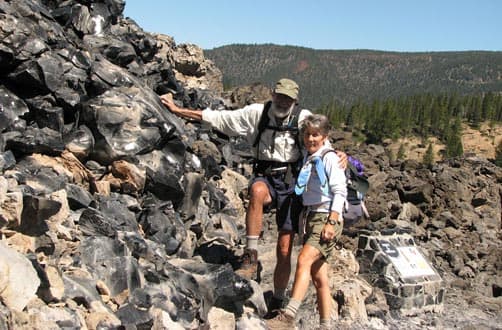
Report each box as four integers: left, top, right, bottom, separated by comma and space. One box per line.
317, 92, 502, 157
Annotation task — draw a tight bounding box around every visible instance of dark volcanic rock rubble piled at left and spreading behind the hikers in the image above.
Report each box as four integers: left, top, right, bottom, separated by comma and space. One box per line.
0, 0, 502, 330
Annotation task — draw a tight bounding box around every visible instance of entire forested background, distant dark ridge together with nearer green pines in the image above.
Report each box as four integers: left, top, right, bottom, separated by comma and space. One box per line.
205, 44, 502, 157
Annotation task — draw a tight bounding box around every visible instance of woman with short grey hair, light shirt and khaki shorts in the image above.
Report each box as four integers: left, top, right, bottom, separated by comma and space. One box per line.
267, 114, 347, 329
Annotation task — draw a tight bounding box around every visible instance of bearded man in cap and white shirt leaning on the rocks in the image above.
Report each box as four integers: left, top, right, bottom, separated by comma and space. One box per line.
161, 78, 346, 309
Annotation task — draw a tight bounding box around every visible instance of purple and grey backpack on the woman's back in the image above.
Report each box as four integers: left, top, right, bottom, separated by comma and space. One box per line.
321, 149, 370, 227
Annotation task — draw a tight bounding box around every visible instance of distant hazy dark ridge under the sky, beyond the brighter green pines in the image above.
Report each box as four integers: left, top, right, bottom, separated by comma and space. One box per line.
204, 44, 502, 108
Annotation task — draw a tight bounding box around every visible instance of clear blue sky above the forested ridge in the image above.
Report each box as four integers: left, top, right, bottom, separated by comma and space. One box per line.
124, 0, 502, 52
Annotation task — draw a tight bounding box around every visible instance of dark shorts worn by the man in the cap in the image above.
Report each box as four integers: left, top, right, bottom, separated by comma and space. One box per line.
249, 175, 303, 232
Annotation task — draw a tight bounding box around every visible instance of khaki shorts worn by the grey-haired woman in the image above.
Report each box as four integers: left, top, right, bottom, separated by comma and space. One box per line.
304, 212, 343, 259
